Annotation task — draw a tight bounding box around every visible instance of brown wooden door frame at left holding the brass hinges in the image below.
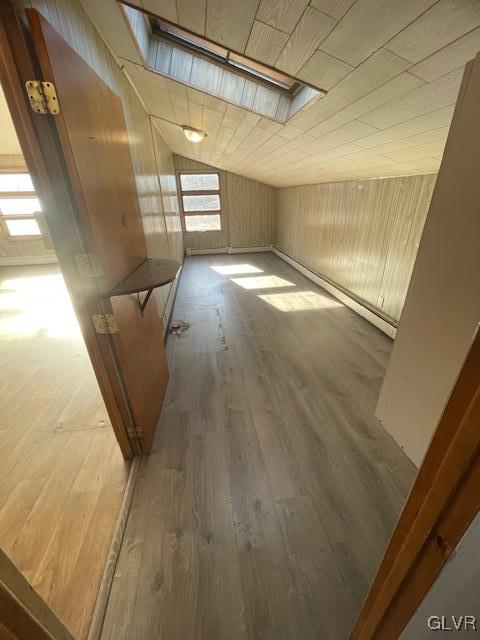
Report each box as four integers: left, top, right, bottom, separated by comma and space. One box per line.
0, 0, 136, 458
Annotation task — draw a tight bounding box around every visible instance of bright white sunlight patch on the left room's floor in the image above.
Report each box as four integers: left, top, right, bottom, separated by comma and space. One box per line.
0, 274, 82, 340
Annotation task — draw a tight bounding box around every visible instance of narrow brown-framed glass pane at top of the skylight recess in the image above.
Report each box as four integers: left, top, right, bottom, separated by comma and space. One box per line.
150, 16, 301, 92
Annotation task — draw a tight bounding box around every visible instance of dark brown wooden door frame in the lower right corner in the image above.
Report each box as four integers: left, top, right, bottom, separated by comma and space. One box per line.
350, 329, 480, 640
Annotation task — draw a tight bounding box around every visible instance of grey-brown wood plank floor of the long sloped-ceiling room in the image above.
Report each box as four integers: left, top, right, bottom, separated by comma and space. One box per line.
102, 253, 415, 640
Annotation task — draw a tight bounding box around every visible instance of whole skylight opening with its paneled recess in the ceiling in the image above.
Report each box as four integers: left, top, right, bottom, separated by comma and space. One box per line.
119, 0, 326, 123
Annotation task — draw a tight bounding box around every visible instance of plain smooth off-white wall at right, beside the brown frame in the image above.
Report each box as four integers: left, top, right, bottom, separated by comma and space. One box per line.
377, 55, 480, 465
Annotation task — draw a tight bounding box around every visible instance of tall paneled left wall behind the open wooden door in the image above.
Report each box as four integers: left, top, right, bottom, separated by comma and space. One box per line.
11, 0, 183, 308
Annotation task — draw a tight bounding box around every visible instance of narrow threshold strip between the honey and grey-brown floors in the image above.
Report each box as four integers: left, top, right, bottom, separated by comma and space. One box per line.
87, 456, 142, 640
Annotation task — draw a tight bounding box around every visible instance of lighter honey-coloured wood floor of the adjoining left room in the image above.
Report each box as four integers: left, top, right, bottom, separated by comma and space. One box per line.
0, 265, 128, 638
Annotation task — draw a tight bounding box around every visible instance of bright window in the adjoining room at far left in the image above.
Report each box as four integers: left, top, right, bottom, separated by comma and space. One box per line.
0, 172, 42, 238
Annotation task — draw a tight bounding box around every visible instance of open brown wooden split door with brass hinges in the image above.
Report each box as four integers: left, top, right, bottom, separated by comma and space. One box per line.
27, 10, 168, 453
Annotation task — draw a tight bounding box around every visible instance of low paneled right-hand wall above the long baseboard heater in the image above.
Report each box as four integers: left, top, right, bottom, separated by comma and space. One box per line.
274, 174, 436, 323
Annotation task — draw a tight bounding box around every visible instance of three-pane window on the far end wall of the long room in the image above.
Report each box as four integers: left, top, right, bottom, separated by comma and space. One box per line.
180, 173, 222, 231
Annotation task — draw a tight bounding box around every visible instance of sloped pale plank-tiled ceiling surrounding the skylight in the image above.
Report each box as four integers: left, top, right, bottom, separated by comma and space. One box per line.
82, 0, 480, 186
